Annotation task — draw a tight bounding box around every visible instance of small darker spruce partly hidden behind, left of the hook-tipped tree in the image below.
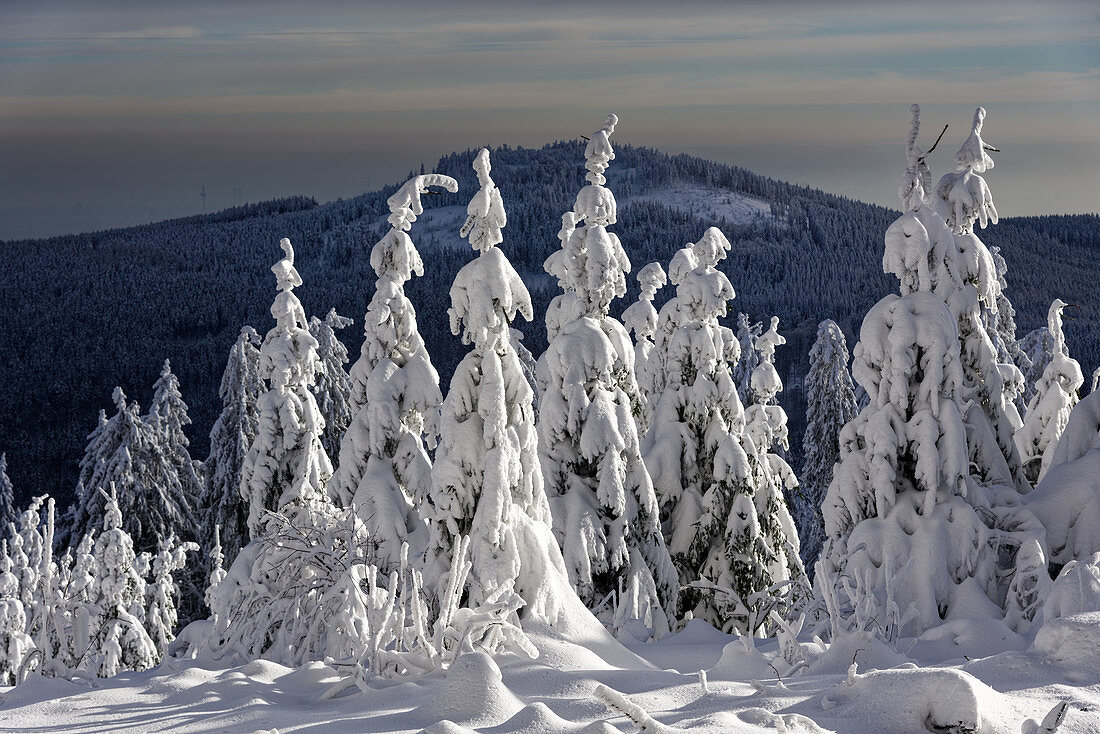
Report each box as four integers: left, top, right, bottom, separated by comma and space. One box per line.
309, 308, 354, 459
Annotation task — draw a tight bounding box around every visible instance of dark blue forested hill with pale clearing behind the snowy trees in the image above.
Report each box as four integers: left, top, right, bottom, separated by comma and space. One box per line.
0, 141, 1100, 500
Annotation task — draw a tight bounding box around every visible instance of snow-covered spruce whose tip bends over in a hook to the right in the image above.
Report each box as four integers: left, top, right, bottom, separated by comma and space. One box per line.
330, 174, 459, 569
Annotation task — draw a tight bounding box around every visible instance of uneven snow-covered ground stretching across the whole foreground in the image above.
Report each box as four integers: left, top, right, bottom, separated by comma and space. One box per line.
0, 613, 1100, 734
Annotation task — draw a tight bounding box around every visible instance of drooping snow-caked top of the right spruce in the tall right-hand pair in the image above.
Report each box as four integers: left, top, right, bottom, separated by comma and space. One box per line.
935, 107, 997, 234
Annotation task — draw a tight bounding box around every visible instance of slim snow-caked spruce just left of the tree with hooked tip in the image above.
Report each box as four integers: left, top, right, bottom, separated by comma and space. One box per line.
241, 238, 332, 538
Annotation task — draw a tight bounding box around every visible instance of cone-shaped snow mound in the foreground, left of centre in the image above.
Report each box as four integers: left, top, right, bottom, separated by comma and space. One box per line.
410, 653, 524, 731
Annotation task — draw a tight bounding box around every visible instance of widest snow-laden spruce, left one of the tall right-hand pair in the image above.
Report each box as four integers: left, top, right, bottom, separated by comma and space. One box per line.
815, 105, 1037, 634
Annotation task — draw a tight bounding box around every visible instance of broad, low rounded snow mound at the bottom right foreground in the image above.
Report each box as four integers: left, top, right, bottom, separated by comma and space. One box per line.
818, 667, 1026, 734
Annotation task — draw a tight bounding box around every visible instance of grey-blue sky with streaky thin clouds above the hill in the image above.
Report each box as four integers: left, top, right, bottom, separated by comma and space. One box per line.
0, 0, 1100, 239
